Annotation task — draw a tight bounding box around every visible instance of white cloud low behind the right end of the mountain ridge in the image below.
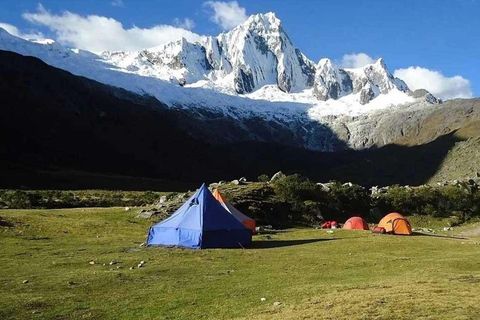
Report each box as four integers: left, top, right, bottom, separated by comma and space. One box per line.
393, 67, 473, 100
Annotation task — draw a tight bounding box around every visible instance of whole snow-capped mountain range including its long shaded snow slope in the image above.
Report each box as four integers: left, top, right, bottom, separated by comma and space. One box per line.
0, 13, 439, 151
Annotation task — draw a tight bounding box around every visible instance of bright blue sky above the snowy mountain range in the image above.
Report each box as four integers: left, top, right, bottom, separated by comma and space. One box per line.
0, 0, 480, 97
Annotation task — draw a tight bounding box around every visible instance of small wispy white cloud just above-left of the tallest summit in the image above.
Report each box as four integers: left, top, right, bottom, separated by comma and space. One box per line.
203, 1, 247, 30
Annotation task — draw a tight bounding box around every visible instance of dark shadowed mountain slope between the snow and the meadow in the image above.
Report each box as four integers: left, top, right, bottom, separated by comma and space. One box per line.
0, 51, 480, 189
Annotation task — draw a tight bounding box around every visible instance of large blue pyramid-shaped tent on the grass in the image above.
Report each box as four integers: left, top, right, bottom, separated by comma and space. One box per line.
147, 184, 252, 249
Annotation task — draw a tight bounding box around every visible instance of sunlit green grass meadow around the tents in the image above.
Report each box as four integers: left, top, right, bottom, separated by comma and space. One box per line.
0, 208, 480, 319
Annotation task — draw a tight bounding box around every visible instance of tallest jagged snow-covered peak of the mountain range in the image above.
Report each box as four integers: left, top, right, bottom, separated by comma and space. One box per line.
218, 13, 314, 93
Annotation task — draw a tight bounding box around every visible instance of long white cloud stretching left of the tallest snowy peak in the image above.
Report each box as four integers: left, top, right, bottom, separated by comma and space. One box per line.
22, 4, 202, 52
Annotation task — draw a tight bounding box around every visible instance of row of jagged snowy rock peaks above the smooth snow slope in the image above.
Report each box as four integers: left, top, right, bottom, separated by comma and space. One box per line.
102, 13, 409, 104
